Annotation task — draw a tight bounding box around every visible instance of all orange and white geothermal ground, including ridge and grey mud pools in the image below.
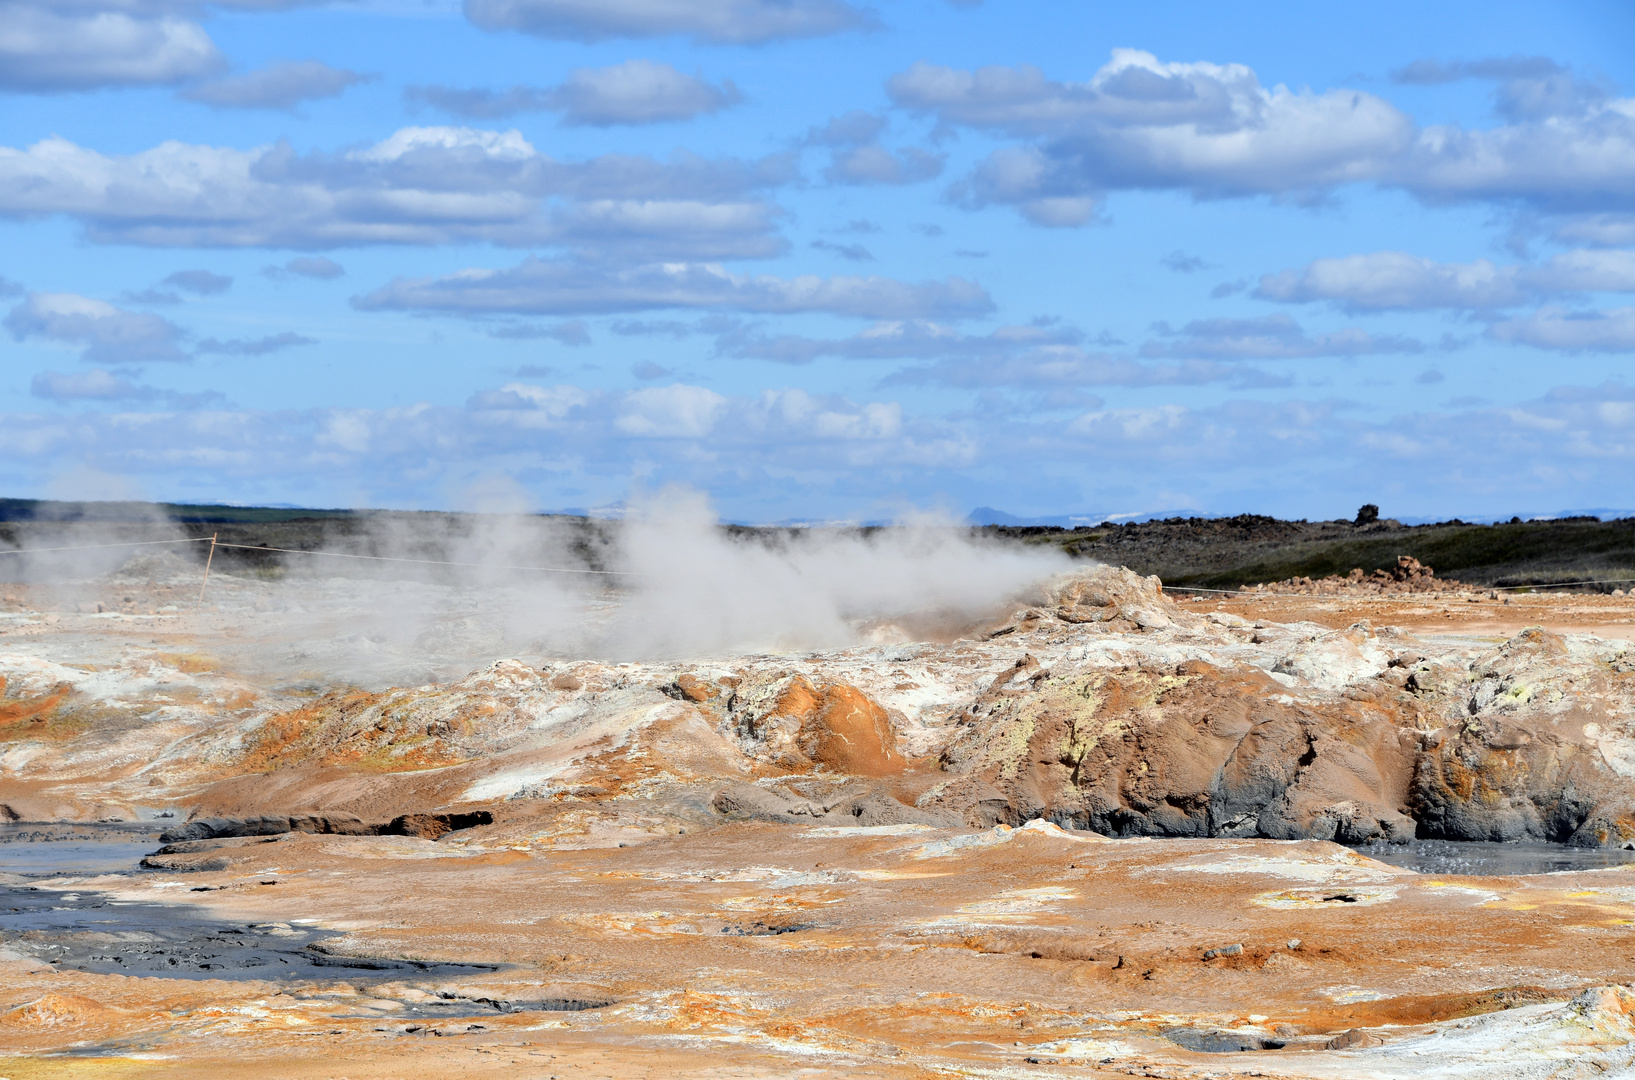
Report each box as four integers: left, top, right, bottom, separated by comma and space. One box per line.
0, 542, 1635, 1080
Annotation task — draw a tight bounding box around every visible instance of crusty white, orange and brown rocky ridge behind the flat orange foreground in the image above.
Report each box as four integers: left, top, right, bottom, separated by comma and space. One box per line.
0, 560, 1635, 846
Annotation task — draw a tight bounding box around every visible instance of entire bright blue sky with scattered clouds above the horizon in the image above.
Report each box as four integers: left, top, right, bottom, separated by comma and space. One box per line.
0, 0, 1635, 521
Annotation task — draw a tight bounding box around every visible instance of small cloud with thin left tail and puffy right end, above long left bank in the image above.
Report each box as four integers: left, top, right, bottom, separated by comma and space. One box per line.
404, 60, 742, 127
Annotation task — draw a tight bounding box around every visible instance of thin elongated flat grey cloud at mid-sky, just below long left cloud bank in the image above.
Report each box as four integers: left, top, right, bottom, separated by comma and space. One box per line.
353, 258, 994, 319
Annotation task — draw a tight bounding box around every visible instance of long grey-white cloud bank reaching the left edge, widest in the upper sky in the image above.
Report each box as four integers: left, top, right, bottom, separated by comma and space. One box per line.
0, 127, 793, 260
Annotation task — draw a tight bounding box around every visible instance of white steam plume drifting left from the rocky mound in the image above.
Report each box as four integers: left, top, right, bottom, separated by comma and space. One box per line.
0, 487, 1069, 690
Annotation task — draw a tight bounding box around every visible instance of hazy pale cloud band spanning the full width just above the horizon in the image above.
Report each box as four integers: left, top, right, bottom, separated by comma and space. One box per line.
0, 374, 1635, 520
